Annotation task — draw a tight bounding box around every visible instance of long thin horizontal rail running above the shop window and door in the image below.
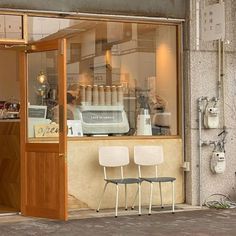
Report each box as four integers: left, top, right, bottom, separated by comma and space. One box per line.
0, 8, 185, 24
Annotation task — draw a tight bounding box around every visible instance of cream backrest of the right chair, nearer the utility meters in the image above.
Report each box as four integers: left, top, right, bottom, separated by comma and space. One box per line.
134, 145, 164, 166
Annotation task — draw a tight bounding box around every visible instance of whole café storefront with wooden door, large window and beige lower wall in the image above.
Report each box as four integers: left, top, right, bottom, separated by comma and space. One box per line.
0, 0, 185, 219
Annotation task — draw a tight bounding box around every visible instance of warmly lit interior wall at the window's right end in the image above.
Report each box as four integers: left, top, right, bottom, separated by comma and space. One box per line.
156, 25, 177, 135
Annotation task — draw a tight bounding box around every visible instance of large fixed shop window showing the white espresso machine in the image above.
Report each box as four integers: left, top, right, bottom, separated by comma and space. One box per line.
27, 18, 179, 136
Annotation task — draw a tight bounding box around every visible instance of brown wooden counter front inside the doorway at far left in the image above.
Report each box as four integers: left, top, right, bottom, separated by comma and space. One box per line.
0, 120, 20, 212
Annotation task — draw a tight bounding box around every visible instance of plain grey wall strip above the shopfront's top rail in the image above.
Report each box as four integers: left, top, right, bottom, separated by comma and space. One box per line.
0, 0, 187, 19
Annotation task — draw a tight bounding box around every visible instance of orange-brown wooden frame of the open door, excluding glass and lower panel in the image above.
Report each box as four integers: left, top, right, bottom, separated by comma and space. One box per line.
19, 39, 68, 220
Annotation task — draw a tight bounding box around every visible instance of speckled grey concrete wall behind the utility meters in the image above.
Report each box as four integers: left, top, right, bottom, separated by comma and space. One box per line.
184, 0, 236, 205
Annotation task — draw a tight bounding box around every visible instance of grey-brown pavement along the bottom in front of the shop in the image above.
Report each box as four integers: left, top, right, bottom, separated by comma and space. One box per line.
0, 207, 236, 236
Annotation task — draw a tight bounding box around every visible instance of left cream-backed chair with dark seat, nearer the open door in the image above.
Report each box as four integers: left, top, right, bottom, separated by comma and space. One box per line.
97, 146, 141, 217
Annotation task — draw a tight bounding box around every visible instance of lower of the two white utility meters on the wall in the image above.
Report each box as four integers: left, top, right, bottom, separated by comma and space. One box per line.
211, 152, 226, 174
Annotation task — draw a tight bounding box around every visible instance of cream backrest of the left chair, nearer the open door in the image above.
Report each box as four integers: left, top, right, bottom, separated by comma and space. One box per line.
99, 146, 129, 167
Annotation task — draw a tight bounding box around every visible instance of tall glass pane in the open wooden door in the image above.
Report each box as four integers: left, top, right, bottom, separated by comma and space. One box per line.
27, 50, 59, 141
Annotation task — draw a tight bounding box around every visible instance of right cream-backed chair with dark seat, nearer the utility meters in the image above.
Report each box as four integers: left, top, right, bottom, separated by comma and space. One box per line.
134, 146, 176, 215
